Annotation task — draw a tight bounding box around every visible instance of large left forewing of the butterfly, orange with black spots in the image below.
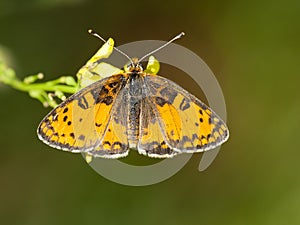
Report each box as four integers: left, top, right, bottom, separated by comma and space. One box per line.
38, 74, 128, 155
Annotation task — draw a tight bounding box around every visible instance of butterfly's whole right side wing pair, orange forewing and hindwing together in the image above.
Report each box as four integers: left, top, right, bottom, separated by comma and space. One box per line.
138, 75, 229, 157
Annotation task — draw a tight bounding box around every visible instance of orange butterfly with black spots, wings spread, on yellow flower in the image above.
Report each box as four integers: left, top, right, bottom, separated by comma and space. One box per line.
37, 31, 229, 158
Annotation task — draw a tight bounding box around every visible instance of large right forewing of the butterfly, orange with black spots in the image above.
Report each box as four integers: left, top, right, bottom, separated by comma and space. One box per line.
140, 75, 228, 153
